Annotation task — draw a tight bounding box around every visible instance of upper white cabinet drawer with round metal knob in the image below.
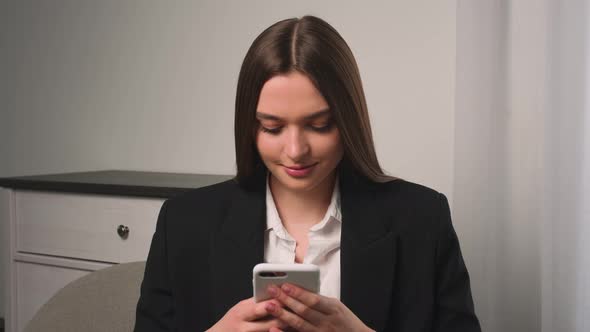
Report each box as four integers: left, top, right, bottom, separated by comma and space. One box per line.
15, 191, 164, 263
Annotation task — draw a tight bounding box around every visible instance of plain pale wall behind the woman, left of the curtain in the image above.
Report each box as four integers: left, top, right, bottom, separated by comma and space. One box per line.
0, 0, 461, 322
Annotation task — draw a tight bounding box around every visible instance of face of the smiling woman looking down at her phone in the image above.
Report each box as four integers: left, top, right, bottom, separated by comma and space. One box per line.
256, 71, 344, 191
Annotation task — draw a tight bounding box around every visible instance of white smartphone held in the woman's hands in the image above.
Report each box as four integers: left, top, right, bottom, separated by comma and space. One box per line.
252, 263, 320, 302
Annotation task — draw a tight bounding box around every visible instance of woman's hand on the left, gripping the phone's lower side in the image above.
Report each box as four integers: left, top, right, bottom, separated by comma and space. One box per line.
207, 298, 288, 332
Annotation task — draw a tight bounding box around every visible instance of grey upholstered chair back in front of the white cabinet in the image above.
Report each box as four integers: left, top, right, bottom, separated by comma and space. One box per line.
25, 262, 145, 332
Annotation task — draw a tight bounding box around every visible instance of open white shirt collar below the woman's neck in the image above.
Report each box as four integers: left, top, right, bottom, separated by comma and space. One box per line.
266, 174, 342, 231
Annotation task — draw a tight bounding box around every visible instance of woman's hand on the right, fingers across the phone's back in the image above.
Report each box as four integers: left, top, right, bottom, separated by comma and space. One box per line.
265, 284, 373, 332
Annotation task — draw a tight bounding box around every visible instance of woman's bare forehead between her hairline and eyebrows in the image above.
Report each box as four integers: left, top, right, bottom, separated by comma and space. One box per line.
257, 71, 328, 119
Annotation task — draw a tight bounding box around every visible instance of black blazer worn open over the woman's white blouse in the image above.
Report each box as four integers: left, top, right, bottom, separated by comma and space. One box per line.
135, 177, 480, 332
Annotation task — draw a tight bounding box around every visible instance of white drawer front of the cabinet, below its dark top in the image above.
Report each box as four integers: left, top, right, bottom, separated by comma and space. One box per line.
0, 189, 164, 331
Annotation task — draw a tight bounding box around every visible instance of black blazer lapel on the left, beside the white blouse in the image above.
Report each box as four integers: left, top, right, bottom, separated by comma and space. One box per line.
209, 182, 266, 320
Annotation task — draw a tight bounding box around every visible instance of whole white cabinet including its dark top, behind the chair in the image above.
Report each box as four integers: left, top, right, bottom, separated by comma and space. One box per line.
0, 170, 233, 332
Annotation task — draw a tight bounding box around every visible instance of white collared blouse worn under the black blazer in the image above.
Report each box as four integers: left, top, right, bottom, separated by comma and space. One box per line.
264, 177, 342, 299
